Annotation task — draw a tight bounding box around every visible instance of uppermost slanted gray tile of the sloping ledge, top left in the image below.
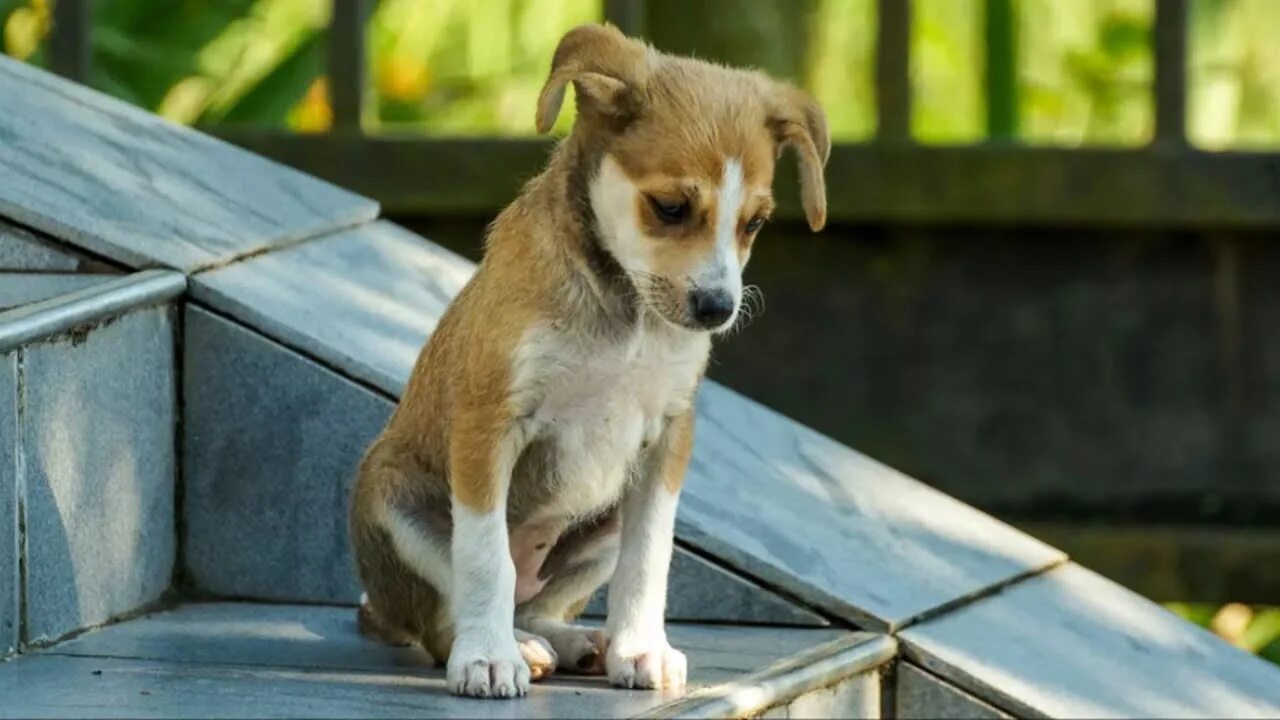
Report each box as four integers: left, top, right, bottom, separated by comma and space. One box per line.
0, 58, 378, 270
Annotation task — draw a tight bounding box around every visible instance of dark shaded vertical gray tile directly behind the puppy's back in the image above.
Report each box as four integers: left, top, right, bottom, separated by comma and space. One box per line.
183, 305, 392, 602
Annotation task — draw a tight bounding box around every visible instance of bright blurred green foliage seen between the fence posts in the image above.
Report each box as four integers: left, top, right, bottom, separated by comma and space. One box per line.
0, 0, 1280, 147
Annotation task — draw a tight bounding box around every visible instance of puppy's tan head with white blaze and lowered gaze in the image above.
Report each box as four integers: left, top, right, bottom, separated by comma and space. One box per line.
538, 26, 831, 332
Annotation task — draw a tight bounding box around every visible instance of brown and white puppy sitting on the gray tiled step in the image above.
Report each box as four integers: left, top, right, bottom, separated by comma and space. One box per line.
351, 20, 829, 697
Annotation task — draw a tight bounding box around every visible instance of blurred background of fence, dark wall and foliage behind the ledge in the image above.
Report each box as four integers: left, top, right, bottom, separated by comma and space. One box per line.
0, 0, 1280, 662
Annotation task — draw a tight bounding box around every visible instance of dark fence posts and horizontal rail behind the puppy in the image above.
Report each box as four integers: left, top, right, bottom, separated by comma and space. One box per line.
42, 0, 1280, 229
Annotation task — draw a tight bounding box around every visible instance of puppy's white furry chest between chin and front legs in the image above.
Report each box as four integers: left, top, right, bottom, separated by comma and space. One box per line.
514, 325, 708, 518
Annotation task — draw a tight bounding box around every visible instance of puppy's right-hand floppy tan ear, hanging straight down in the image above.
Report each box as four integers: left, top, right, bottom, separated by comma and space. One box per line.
768, 83, 831, 232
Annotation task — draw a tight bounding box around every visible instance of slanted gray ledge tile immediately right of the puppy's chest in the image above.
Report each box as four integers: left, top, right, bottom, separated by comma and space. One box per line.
677, 383, 1062, 629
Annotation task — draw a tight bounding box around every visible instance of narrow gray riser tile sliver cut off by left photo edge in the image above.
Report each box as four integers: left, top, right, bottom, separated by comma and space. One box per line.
0, 352, 20, 657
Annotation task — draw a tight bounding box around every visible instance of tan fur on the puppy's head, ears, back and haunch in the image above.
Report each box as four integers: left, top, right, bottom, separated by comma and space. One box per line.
351, 26, 829, 661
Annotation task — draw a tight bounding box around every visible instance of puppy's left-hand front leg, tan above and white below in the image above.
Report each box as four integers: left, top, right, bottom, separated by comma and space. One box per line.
447, 410, 529, 697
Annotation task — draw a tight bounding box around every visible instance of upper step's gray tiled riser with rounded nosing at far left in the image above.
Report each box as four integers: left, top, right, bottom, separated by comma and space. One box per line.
0, 270, 186, 656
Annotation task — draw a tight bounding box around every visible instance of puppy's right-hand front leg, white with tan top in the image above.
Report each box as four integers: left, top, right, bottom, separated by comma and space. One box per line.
604, 410, 694, 688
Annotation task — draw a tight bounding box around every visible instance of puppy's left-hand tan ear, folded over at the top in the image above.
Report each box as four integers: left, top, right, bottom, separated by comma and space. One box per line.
538, 24, 648, 133
